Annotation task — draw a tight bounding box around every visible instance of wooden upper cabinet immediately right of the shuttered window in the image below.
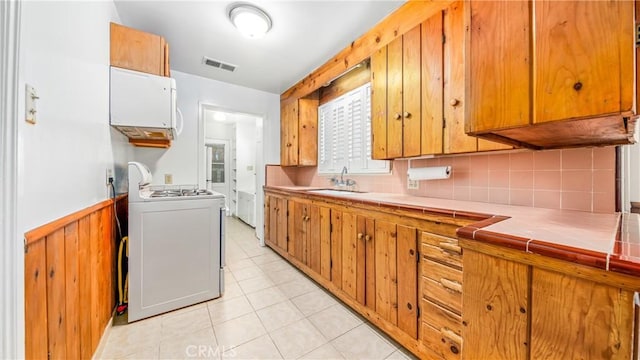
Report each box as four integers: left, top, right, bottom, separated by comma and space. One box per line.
371, 1, 511, 159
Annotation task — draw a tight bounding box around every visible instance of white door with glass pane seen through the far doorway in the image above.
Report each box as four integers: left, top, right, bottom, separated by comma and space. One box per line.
205, 140, 231, 209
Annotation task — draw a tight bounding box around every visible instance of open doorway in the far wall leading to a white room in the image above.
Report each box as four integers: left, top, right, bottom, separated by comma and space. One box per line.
201, 104, 263, 228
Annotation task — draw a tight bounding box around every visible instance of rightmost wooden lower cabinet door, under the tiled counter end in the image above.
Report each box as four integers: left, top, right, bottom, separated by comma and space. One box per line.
528, 268, 633, 359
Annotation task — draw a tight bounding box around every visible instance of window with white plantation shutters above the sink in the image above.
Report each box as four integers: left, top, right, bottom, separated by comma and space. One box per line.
318, 84, 389, 174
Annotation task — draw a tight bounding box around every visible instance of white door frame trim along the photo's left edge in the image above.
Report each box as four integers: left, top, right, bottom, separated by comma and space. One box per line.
0, 1, 25, 359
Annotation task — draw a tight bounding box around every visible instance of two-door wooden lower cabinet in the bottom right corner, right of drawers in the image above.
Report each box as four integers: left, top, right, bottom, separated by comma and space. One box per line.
462, 245, 638, 360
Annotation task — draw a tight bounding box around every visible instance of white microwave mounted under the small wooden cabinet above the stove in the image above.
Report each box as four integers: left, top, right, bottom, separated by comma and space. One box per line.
109, 66, 178, 140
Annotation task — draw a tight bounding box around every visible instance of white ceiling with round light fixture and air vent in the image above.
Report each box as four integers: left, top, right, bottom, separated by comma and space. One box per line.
115, 0, 404, 94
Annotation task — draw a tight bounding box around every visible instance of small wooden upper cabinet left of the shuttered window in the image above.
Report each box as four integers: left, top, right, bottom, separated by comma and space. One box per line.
280, 92, 319, 166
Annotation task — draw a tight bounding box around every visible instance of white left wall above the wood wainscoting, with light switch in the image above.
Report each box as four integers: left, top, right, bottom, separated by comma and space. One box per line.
17, 1, 127, 356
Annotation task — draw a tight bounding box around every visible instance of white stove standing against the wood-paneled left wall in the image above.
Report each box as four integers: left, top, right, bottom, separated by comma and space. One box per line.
128, 162, 226, 322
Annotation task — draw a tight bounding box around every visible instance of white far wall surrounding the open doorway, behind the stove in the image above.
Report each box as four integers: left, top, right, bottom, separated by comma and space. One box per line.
134, 70, 280, 242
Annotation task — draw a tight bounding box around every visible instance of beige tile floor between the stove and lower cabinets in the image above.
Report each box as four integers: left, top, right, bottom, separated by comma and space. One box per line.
98, 218, 415, 359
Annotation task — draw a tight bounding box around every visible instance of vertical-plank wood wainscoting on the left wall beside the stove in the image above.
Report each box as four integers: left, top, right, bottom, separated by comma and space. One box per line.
25, 197, 126, 359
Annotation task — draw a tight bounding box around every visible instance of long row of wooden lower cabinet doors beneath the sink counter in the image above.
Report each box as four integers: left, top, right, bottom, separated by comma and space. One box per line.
265, 192, 461, 358
